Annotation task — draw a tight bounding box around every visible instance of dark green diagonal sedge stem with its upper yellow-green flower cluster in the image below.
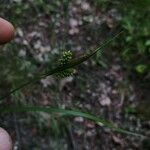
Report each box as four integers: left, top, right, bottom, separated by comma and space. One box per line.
0, 32, 119, 100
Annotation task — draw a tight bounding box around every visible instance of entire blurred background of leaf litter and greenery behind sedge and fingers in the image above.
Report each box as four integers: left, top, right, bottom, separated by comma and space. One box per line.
0, 0, 150, 150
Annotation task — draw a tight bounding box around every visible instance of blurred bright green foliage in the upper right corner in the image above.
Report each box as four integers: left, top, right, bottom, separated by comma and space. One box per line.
94, 0, 150, 81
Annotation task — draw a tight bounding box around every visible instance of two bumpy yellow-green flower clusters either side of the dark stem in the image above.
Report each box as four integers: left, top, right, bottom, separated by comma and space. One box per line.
56, 50, 74, 78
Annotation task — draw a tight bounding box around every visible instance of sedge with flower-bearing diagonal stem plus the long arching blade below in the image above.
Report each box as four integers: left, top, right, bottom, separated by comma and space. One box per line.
0, 31, 143, 136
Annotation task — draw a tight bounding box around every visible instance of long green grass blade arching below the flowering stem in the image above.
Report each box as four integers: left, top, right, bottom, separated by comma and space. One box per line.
0, 106, 144, 137
